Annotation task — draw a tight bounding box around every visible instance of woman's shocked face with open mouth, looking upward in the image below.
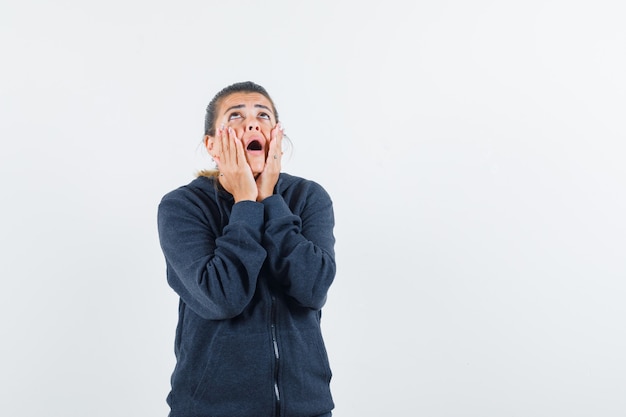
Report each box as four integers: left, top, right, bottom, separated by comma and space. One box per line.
206, 92, 276, 175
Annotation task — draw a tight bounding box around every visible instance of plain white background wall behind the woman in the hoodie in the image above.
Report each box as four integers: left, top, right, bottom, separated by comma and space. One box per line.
0, 0, 626, 417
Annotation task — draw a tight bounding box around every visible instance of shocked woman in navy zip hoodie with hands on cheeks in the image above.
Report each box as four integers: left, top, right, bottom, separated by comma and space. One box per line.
158, 82, 335, 417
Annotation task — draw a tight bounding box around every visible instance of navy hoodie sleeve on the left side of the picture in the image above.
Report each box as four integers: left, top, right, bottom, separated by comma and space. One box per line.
157, 190, 266, 320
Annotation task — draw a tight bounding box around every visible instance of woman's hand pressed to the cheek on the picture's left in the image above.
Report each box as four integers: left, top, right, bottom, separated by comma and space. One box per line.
214, 126, 259, 203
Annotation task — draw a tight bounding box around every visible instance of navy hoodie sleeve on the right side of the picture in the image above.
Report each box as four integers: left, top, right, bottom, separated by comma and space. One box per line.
263, 181, 336, 310
